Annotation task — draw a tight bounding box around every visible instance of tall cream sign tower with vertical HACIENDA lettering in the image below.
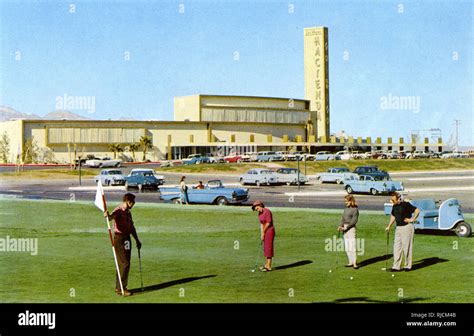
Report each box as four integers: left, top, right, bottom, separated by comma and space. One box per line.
304, 27, 330, 140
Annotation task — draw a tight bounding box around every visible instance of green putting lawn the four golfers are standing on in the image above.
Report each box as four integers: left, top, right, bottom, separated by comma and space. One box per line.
0, 199, 474, 303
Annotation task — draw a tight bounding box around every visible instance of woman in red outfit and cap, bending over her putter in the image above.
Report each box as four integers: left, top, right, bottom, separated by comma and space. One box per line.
252, 201, 275, 272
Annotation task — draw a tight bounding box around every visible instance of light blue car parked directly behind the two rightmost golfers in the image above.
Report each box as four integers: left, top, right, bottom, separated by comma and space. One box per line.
343, 174, 404, 195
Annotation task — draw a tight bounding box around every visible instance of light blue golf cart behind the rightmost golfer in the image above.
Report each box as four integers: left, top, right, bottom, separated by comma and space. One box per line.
384, 198, 472, 237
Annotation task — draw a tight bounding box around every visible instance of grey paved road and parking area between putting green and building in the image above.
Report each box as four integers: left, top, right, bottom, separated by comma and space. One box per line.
0, 165, 474, 213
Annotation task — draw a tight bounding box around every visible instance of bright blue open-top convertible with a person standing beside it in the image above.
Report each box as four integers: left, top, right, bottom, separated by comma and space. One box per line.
160, 180, 250, 205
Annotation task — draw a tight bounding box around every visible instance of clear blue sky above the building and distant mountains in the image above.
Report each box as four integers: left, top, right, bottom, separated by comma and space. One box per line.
0, 0, 474, 145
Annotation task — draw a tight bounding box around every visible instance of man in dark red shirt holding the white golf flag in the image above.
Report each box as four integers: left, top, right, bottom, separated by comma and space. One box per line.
104, 193, 142, 296
